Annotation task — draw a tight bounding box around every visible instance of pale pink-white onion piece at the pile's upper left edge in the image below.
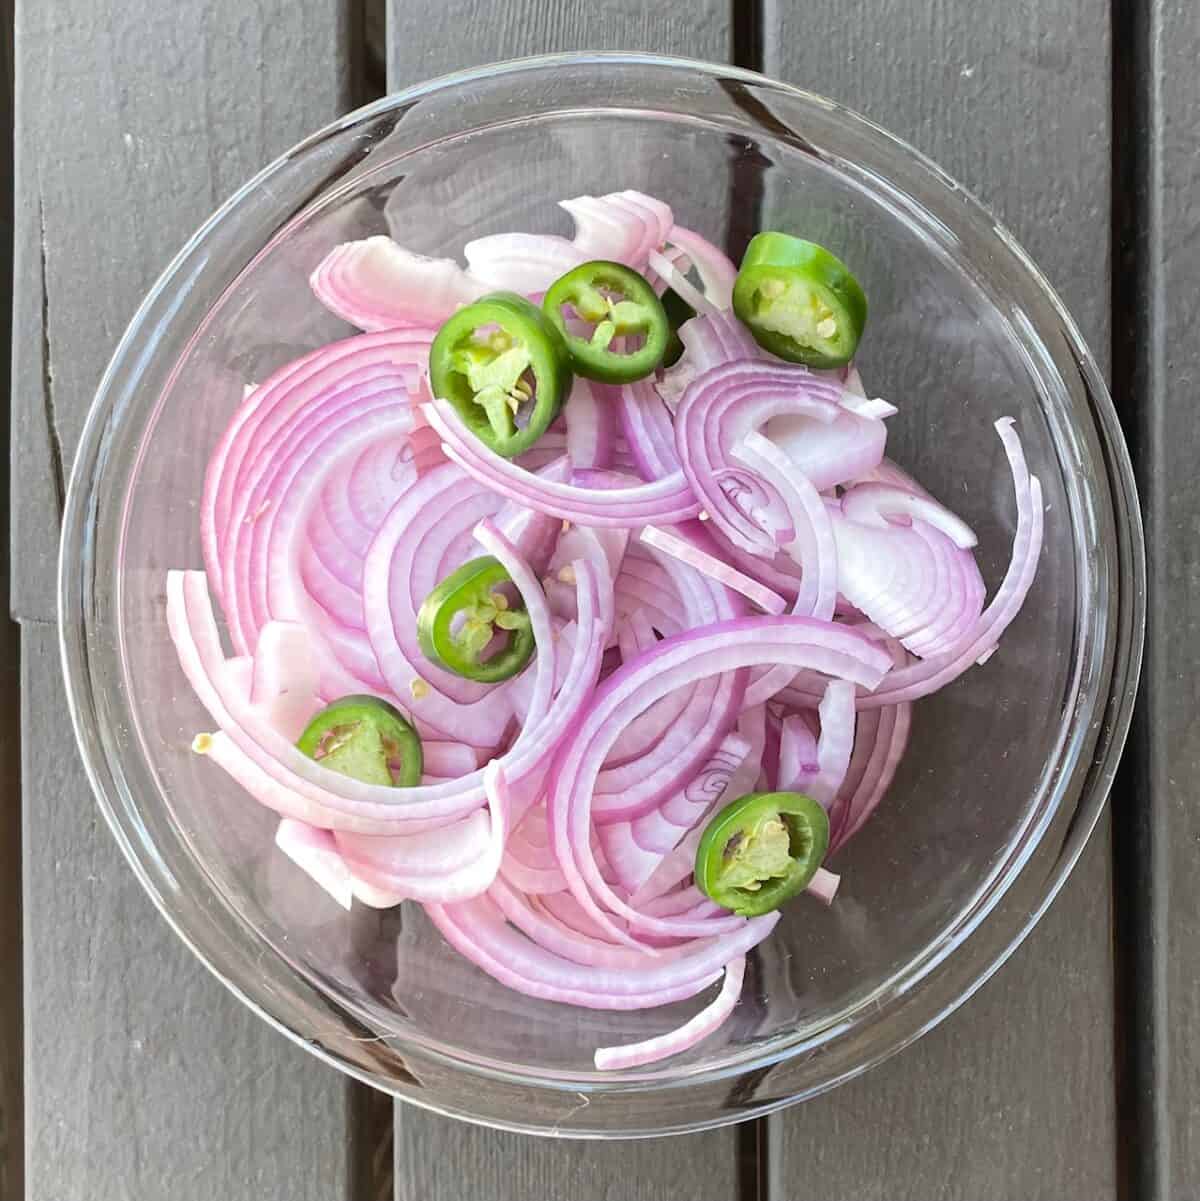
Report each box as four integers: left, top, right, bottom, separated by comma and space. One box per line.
309, 234, 488, 330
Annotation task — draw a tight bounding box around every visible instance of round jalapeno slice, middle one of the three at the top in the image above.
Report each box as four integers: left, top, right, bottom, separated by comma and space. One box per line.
542, 258, 670, 383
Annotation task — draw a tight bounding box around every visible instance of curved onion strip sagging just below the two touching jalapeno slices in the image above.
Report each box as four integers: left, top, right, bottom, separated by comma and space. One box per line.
424, 400, 699, 528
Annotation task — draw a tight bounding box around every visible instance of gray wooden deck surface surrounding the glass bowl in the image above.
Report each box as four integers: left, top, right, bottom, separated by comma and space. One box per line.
0, 0, 1200, 1201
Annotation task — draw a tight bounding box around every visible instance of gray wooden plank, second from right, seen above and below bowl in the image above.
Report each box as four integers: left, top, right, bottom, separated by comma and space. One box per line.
764, 0, 1116, 1201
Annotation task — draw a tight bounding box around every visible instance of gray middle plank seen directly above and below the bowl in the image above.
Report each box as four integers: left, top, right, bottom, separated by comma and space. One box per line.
388, 7, 738, 1201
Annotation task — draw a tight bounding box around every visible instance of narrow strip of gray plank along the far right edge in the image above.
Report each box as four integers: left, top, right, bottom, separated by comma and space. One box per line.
1153, 0, 1200, 1201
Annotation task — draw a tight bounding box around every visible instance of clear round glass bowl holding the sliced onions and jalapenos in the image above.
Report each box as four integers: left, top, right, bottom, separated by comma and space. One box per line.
60, 55, 1145, 1137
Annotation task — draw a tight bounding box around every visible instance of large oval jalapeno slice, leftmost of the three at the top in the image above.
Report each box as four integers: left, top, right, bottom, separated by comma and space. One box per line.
429, 292, 571, 459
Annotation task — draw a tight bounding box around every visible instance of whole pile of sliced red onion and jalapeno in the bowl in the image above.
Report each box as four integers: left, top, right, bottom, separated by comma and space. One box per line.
167, 191, 1043, 1069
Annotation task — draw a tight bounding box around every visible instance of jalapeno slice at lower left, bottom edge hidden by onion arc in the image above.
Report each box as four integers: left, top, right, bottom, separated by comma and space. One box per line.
295, 695, 424, 788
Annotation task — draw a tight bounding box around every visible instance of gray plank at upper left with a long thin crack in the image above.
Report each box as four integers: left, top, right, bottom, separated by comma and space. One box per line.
11, 0, 352, 620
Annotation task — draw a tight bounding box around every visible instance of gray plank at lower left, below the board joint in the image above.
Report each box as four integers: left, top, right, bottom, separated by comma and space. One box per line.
22, 623, 351, 1201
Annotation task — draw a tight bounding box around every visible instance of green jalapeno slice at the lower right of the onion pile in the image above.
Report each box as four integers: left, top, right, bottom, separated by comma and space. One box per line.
695, 793, 829, 918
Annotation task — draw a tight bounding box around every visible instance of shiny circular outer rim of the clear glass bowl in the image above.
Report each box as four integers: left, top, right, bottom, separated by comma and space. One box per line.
58, 52, 1146, 1137
